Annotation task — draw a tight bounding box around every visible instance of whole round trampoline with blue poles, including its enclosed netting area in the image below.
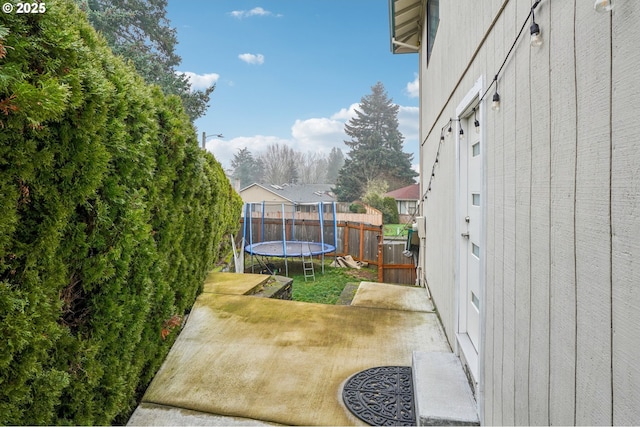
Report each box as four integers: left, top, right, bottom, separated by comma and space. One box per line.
243, 202, 338, 276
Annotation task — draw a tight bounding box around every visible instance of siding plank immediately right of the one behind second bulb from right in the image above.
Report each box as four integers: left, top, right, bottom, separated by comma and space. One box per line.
549, 2, 576, 425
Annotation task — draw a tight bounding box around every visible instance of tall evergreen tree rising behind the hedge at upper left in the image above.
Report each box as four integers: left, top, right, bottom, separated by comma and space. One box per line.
75, 0, 215, 122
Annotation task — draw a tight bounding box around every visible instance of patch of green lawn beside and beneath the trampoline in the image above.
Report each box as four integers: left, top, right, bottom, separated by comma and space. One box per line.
272, 261, 378, 304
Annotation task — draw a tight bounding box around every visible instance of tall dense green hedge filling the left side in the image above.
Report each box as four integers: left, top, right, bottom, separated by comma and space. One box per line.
0, 0, 241, 425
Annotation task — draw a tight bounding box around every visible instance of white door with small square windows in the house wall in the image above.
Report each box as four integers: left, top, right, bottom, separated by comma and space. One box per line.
459, 114, 484, 352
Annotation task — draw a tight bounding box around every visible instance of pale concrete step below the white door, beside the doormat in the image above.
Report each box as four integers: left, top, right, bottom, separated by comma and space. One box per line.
413, 351, 480, 426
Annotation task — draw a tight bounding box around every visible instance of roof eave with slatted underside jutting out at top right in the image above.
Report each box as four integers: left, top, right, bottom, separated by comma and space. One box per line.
389, 0, 424, 53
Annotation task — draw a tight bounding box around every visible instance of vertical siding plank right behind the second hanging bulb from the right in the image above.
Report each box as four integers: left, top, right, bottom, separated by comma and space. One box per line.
528, 0, 551, 425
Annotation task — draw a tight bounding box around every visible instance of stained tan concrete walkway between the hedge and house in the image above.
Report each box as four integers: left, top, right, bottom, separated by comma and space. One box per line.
129, 273, 450, 425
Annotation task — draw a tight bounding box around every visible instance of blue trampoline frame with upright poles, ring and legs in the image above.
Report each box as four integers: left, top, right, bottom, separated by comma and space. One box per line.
242, 201, 338, 276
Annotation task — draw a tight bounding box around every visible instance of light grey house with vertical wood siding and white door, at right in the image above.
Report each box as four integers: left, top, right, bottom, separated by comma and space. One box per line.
389, 0, 640, 425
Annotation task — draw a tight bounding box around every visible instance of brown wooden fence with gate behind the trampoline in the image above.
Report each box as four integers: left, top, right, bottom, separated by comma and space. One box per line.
239, 218, 416, 284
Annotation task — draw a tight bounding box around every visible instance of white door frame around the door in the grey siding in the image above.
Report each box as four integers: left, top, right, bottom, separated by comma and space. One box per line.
455, 76, 487, 392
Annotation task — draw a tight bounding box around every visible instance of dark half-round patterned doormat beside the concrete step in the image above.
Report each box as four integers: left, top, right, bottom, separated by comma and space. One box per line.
342, 366, 416, 426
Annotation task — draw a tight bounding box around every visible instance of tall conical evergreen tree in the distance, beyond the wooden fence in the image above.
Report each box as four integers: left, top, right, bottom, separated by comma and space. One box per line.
334, 82, 418, 201
